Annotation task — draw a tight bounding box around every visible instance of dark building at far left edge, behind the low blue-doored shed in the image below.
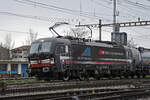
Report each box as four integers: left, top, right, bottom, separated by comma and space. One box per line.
0, 46, 9, 60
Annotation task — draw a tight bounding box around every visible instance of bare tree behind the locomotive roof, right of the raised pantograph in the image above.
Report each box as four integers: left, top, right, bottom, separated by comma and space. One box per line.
66, 28, 89, 38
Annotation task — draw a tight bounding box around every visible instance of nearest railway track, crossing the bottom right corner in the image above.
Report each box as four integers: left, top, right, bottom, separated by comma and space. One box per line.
43, 88, 150, 100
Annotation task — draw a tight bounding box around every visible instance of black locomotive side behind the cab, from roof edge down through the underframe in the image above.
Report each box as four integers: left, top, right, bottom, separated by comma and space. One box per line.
67, 44, 131, 77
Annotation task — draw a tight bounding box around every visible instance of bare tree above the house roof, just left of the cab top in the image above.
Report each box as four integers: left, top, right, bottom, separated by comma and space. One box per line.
26, 29, 38, 45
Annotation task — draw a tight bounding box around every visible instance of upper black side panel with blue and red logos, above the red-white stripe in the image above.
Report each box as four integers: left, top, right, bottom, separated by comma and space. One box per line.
72, 44, 127, 62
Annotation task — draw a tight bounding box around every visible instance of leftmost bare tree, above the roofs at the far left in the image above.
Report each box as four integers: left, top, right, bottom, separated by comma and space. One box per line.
3, 34, 15, 50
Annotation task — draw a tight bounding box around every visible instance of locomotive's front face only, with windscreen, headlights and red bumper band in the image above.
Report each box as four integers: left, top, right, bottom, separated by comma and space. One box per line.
28, 39, 55, 77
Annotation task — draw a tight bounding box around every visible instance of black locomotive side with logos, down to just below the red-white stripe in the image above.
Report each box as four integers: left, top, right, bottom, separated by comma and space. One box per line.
69, 44, 131, 69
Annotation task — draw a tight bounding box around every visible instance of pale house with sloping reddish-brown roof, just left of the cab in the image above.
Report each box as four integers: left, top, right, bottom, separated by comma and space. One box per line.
11, 45, 30, 61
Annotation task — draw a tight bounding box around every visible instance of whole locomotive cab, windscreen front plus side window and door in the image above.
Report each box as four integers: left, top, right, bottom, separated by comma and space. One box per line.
27, 38, 70, 80
